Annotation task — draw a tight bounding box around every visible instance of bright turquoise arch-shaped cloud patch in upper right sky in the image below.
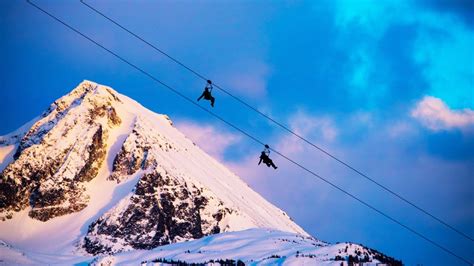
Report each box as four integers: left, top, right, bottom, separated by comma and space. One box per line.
332, 0, 474, 108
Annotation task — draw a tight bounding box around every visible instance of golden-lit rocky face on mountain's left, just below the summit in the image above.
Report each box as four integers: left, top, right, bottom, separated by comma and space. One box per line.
0, 84, 121, 221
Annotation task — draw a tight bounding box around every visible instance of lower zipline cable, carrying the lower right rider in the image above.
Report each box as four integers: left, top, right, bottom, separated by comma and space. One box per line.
26, 0, 472, 265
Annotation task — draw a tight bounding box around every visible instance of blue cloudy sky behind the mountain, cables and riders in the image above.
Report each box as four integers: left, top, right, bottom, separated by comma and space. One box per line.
0, 0, 474, 265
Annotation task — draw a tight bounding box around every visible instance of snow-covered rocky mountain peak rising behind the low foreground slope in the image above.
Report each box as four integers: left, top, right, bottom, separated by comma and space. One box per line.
0, 81, 400, 264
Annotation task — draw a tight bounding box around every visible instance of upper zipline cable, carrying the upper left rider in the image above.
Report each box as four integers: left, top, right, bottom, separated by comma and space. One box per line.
80, 0, 474, 242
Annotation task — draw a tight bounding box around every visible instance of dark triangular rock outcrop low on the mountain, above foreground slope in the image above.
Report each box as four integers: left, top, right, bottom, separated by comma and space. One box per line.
85, 172, 220, 254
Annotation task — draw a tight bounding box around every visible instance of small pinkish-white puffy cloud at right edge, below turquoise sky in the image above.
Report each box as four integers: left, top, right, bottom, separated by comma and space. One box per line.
411, 96, 474, 131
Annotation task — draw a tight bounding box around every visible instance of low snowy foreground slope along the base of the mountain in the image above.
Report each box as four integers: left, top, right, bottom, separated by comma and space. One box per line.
0, 228, 400, 266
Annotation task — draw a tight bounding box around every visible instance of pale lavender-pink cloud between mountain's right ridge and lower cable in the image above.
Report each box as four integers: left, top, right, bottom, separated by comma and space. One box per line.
176, 121, 241, 161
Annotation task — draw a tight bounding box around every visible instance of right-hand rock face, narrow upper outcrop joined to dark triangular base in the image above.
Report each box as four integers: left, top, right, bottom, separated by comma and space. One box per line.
84, 119, 233, 254
